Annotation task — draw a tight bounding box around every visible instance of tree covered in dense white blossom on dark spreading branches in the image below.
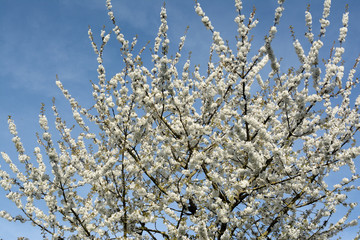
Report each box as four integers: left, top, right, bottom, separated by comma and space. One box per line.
0, 0, 360, 239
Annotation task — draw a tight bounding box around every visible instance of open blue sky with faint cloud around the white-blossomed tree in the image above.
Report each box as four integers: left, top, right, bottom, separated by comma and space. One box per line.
0, 0, 360, 239
